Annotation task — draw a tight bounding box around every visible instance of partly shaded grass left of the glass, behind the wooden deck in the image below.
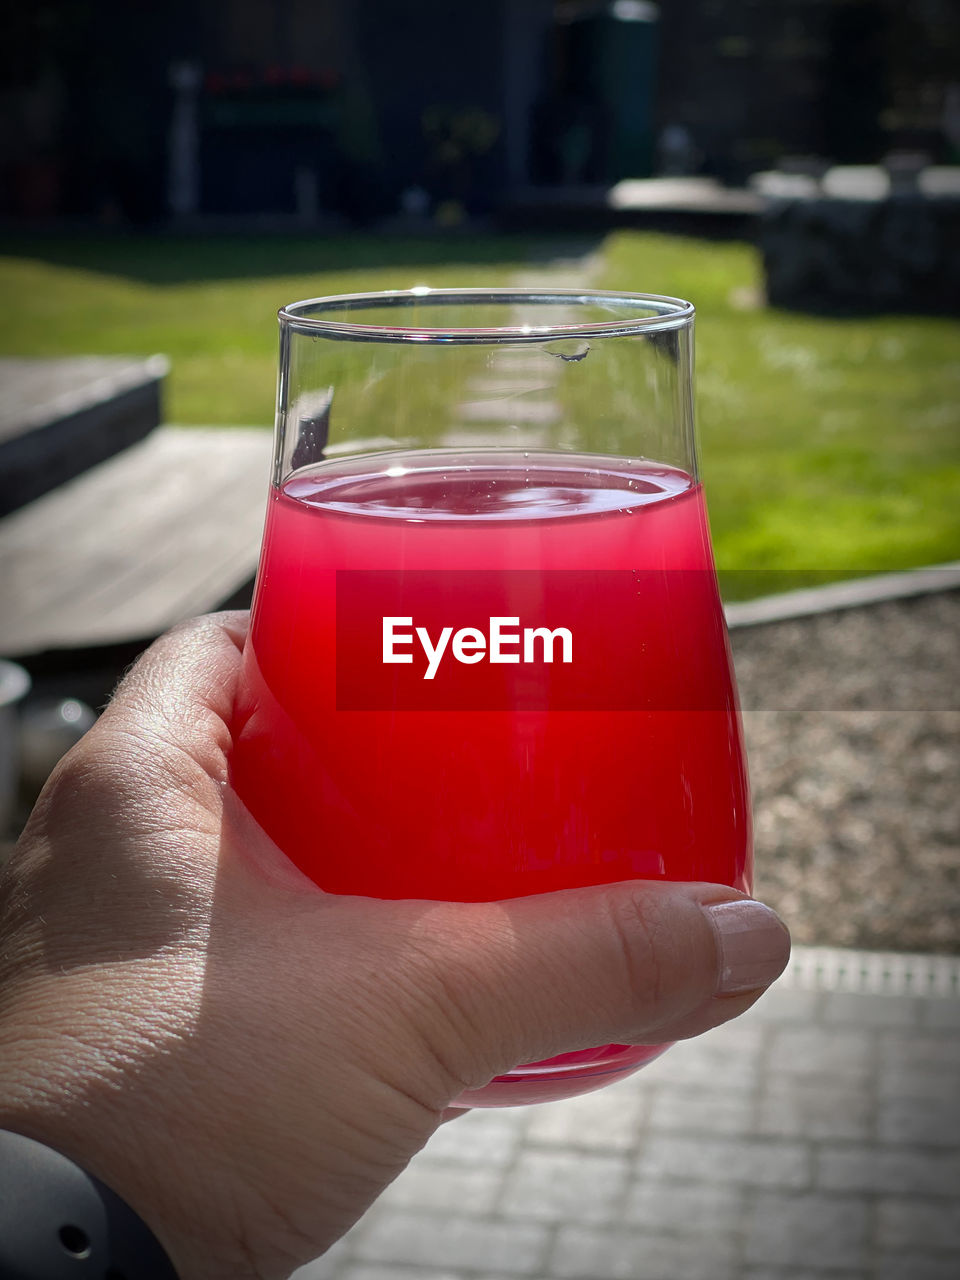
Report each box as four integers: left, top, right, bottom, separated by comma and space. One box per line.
0, 236, 542, 425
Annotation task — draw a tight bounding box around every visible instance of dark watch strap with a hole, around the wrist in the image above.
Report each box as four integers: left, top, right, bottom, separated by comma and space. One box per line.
0, 1130, 177, 1280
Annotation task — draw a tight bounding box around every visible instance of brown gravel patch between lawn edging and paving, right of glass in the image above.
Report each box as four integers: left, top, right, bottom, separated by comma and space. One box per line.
731, 591, 960, 954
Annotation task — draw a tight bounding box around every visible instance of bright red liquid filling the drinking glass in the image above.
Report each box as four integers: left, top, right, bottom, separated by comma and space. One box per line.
233, 452, 751, 1106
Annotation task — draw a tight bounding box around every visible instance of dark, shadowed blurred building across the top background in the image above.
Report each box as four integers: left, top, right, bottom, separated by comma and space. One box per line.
0, 0, 960, 224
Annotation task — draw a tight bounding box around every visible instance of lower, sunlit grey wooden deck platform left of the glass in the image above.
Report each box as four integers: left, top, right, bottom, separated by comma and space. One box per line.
0, 426, 271, 658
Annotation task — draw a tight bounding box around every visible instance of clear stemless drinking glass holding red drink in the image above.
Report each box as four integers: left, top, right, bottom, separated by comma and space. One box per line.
232, 288, 751, 1107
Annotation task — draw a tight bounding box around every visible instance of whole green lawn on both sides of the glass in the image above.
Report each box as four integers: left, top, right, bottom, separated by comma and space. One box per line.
0, 233, 960, 598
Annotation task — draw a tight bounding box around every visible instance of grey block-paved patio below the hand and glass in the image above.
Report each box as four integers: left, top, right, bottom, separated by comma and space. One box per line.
297, 947, 960, 1280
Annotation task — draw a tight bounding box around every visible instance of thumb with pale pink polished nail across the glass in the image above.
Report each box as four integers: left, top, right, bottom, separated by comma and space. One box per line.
417, 881, 790, 1088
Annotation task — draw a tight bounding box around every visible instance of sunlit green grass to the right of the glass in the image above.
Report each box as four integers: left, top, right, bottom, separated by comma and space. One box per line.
602, 233, 960, 598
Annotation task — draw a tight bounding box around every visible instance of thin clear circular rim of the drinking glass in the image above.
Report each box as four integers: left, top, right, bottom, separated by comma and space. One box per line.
276, 285, 695, 344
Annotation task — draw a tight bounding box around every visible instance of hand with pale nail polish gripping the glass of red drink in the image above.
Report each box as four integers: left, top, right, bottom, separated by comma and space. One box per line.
0, 614, 788, 1280
